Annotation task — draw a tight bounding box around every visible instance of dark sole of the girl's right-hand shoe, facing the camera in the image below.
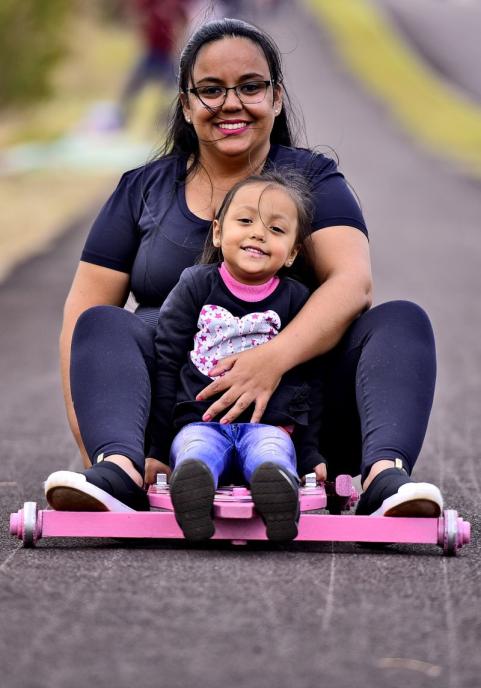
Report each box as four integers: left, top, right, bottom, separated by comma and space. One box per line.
251, 461, 300, 542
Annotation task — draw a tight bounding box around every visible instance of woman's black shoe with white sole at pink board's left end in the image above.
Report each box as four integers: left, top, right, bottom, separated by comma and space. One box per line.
45, 461, 150, 511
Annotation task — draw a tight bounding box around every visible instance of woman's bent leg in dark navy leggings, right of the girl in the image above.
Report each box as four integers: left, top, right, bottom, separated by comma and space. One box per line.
320, 301, 440, 515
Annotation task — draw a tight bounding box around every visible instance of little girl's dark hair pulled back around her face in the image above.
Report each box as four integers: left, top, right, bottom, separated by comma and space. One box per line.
199, 170, 313, 274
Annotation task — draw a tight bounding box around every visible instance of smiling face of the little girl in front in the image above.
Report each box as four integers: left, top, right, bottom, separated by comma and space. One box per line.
213, 182, 299, 284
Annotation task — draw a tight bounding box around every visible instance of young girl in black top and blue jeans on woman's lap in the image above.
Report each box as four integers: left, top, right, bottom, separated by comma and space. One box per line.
149, 173, 323, 540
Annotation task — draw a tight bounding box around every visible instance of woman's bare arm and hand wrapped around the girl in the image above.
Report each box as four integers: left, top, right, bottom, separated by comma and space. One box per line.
197, 226, 372, 423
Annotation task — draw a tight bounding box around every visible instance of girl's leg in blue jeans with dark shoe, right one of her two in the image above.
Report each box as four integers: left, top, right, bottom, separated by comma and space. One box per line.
235, 423, 300, 542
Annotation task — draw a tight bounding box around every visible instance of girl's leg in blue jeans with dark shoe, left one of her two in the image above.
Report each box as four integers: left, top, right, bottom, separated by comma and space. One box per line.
170, 423, 234, 540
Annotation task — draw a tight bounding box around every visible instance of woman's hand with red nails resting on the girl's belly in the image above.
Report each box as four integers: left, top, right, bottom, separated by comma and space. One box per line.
196, 346, 284, 423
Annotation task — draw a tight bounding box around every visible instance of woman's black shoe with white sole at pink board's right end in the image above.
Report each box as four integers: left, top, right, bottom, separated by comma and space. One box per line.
356, 468, 443, 518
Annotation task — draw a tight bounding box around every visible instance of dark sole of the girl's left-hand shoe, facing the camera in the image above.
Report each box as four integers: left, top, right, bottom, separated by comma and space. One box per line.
170, 459, 215, 541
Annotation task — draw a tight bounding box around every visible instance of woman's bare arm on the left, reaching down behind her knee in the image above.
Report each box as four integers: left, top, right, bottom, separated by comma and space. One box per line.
60, 261, 130, 468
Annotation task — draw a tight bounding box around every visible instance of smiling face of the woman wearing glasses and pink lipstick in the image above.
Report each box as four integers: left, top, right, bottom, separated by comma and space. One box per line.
181, 38, 282, 160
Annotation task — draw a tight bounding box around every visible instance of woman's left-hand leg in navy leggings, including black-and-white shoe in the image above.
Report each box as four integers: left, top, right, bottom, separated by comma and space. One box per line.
46, 306, 155, 510
